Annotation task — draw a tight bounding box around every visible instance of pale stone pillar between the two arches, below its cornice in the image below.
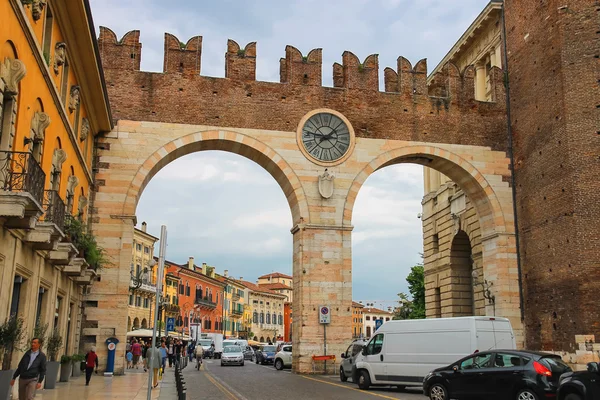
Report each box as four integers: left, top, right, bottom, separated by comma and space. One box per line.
292, 224, 352, 373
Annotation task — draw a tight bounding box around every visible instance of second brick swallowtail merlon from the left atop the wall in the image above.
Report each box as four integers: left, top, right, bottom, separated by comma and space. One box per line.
163, 33, 202, 75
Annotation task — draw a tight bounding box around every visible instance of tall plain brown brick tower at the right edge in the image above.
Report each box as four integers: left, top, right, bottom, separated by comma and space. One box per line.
506, 0, 600, 352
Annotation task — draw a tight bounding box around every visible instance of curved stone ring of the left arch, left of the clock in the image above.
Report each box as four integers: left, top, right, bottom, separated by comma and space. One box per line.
123, 130, 310, 225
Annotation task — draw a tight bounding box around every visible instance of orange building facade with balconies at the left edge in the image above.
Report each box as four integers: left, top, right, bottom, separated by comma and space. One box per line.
0, 0, 112, 378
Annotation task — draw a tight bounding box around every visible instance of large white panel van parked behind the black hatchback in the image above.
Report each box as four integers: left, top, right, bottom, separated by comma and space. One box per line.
352, 317, 516, 389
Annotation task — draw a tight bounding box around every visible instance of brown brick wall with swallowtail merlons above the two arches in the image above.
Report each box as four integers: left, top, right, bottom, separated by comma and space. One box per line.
99, 27, 507, 150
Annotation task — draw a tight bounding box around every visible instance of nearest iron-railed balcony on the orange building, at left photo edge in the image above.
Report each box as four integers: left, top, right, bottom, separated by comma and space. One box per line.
0, 151, 46, 229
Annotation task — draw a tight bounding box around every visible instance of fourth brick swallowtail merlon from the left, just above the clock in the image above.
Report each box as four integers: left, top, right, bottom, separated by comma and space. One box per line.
280, 45, 323, 86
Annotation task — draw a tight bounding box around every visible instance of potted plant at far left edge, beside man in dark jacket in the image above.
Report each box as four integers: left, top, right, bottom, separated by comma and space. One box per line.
0, 315, 25, 400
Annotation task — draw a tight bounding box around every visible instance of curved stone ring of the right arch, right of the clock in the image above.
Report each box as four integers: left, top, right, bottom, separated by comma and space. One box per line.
343, 145, 514, 236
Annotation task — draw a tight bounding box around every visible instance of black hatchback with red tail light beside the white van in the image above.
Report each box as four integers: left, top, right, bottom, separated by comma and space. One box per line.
423, 350, 571, 400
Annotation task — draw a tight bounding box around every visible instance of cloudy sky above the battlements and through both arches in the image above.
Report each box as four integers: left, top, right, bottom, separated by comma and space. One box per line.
90, 0, 488, 306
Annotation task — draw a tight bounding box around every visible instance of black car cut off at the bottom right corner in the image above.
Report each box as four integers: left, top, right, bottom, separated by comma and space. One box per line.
558, 363, 600, 400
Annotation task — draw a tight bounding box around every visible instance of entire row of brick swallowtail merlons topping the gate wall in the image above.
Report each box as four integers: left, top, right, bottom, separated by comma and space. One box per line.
98, 27, 505, 104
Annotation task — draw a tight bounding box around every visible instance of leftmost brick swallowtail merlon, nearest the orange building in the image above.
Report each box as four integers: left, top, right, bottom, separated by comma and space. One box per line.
98, 26, 142, 71
